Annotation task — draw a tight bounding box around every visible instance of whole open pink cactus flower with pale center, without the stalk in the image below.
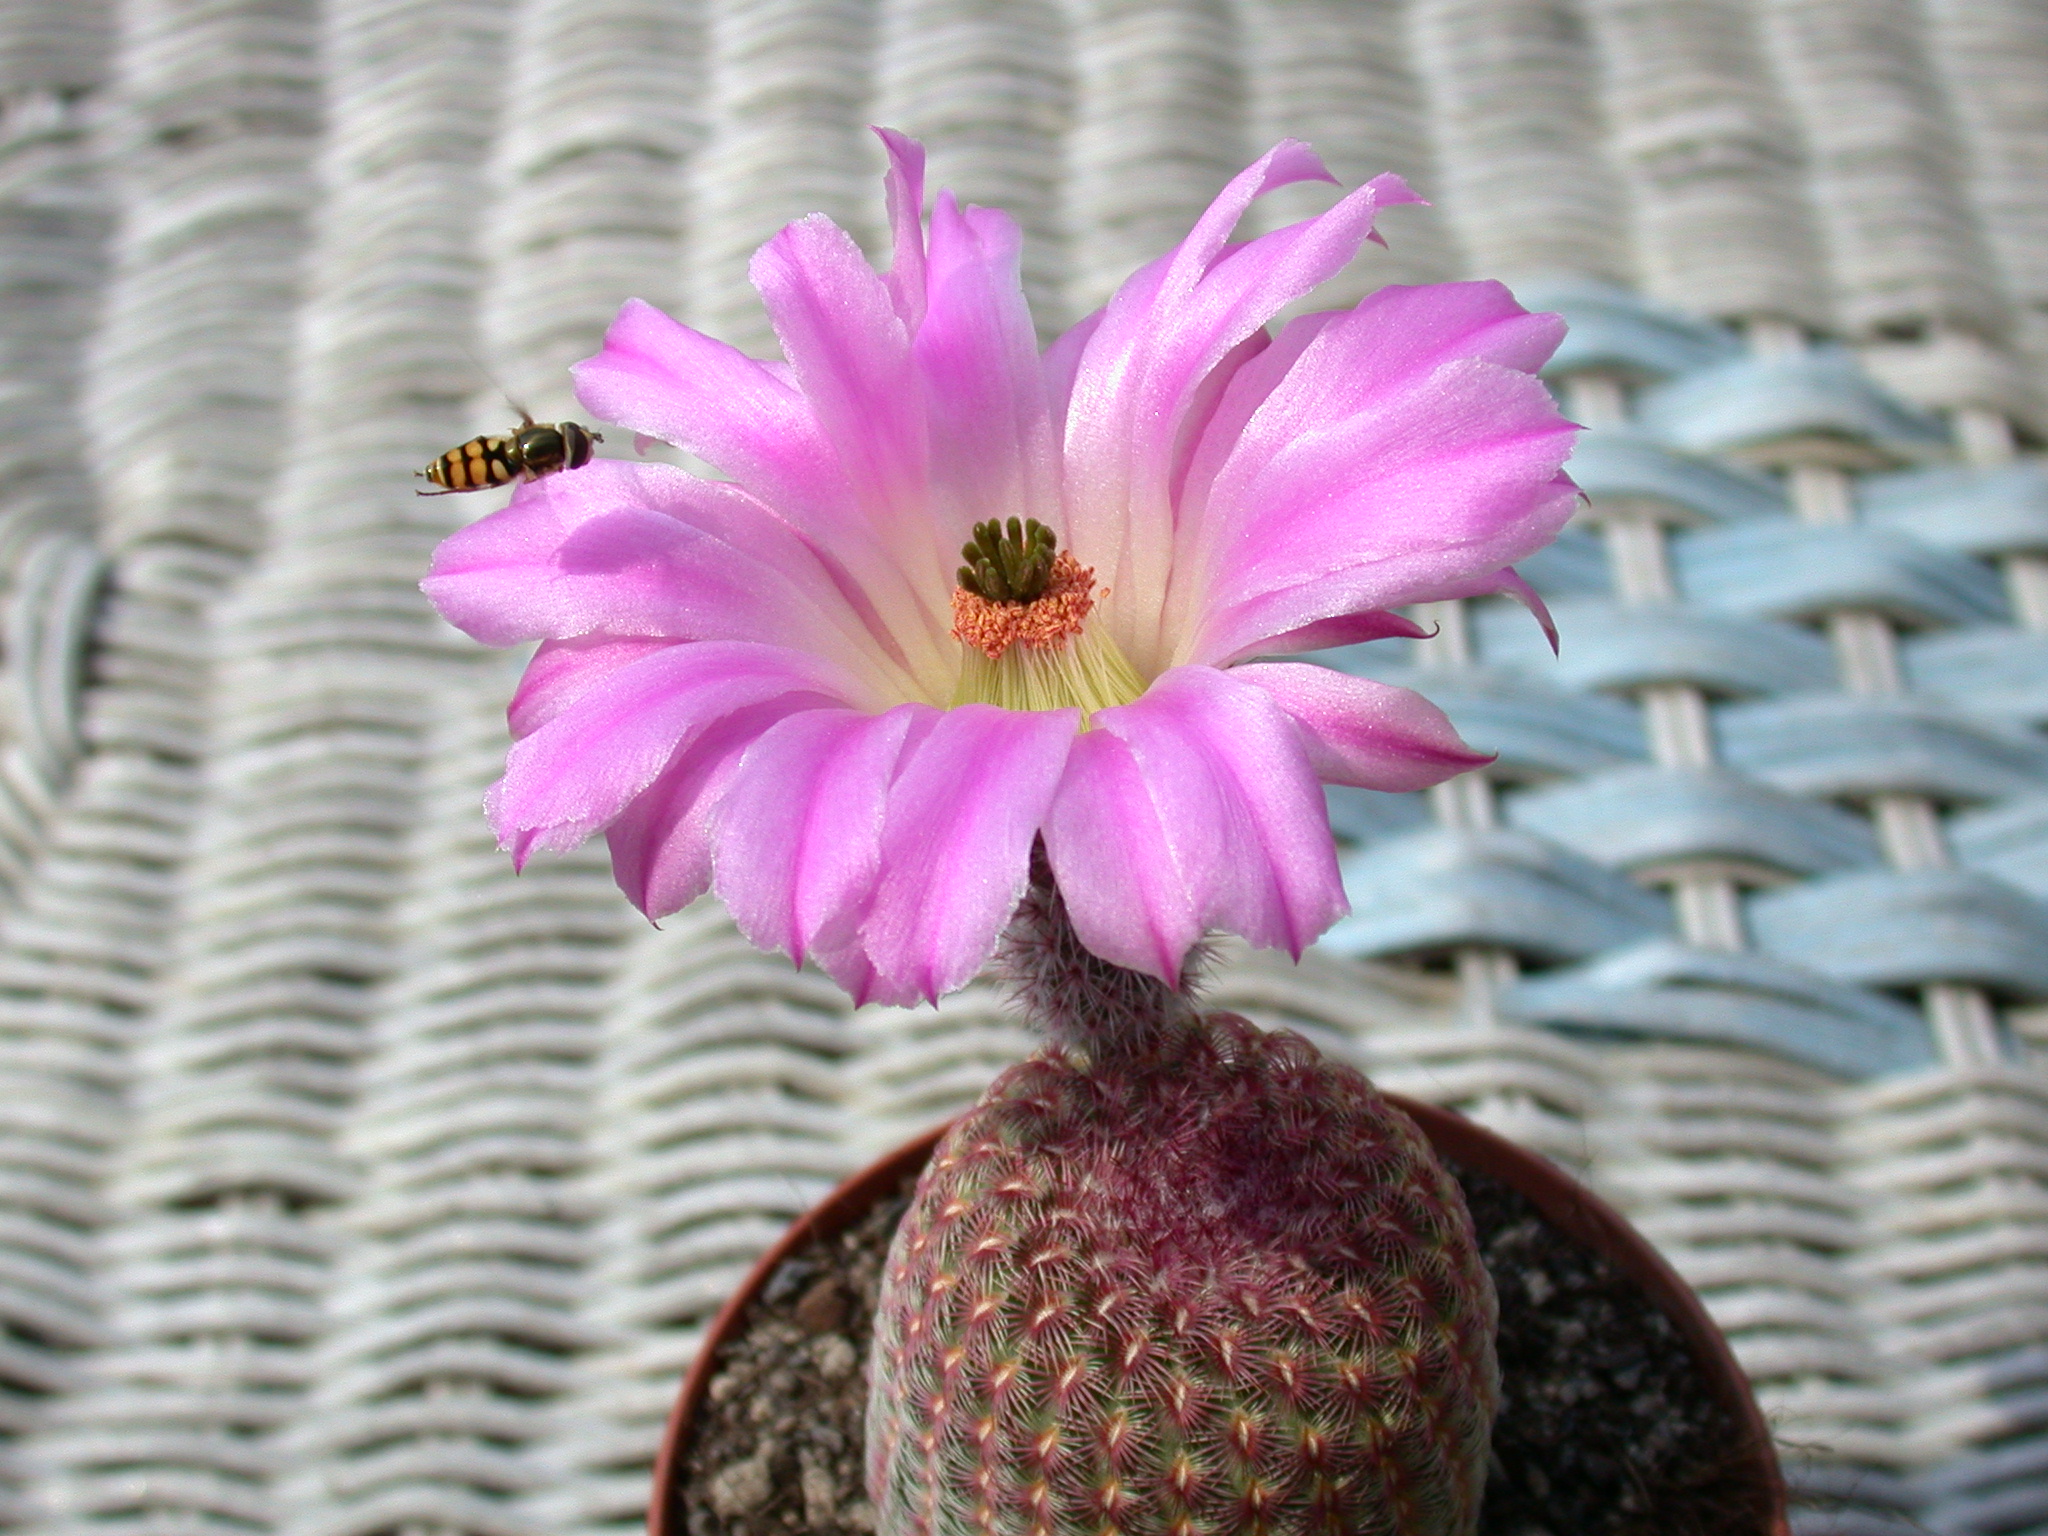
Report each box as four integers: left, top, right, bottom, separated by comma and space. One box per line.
426, 131, 1577, 1001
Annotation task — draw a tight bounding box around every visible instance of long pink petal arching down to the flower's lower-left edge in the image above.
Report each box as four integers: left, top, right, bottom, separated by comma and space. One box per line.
485, 641, 844, 868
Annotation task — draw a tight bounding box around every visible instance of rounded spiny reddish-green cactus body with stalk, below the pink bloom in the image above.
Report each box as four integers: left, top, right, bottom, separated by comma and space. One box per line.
868, 864, 1497, 1536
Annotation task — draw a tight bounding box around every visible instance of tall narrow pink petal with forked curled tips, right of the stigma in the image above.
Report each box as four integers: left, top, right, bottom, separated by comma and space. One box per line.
1065, 139, 1417, 668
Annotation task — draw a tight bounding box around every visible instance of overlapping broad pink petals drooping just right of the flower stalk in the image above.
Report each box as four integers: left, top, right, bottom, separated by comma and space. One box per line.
1047, 668, 1346, 979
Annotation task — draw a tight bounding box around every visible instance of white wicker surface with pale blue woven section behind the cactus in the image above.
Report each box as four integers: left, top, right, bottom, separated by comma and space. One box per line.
0, 0, 2048, 1536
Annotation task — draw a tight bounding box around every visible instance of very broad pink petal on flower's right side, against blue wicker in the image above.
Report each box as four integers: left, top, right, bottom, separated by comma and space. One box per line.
1169, 283, 1577, 659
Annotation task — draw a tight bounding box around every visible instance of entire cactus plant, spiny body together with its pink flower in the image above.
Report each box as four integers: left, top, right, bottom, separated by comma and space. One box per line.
424, 131, 1577, 1536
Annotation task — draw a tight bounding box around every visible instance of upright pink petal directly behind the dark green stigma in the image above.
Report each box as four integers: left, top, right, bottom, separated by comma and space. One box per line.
915, 193, 1065, 549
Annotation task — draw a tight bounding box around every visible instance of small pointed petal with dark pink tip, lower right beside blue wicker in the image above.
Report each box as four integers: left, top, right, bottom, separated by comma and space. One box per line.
1231, 662, 1493, 795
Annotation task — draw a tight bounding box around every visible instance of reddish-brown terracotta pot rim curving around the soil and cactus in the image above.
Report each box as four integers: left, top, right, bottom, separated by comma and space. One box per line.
647, 1094, 1788, 1536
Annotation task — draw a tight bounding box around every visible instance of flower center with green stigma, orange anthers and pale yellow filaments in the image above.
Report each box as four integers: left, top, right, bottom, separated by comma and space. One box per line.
952, 518, 1145, 729
